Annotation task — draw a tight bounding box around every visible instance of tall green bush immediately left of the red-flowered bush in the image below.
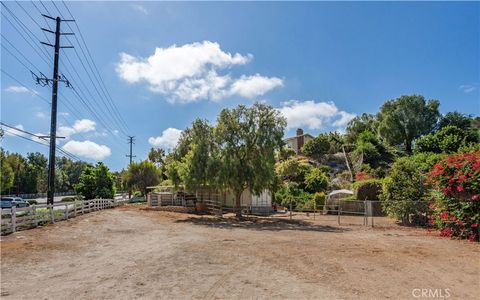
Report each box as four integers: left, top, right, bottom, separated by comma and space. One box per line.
381, 157, 427, 225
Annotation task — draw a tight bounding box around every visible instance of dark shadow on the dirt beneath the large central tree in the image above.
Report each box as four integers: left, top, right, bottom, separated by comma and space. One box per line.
175, 217, 350, 233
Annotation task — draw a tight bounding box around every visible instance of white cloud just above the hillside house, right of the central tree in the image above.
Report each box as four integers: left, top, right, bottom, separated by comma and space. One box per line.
279, 100, 355, 130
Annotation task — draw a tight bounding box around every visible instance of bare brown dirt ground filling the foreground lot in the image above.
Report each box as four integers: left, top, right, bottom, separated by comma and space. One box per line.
1, 205, 480, 299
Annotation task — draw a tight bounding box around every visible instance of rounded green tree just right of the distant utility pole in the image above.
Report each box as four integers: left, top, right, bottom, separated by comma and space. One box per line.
124, 160, 160, 195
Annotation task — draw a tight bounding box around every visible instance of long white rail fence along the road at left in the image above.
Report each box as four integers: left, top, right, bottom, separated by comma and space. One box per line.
0, 199, 128, 235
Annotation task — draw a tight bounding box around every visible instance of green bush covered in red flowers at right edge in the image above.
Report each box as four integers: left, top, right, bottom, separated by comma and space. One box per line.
429, 151, 480, 241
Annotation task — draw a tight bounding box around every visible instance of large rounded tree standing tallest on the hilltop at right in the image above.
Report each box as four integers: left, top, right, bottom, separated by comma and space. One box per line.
378, 95, 440, 153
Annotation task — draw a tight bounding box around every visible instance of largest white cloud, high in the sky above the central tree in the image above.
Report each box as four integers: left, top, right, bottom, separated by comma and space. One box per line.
116, 41, 283, 103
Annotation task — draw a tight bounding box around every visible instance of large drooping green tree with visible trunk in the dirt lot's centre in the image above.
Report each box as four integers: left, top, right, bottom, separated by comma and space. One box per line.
215, 103, 286, 217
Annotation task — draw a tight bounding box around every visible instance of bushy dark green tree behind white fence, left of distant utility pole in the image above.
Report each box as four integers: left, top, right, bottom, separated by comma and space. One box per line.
75, 162, 115, 200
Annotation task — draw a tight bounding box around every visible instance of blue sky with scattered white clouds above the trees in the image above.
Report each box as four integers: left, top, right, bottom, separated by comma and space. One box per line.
1, 2, 480, 170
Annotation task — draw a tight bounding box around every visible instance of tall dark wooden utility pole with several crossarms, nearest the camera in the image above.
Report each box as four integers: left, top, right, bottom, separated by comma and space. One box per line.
35, 15, 74, 205
